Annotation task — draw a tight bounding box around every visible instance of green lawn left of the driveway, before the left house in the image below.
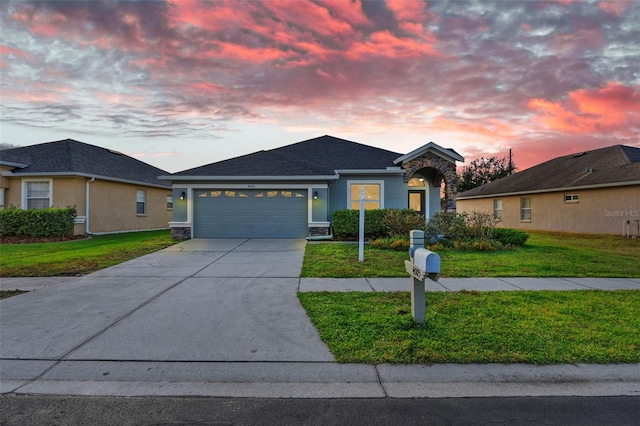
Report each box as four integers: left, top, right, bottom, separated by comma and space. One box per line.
0, 230, 178, 277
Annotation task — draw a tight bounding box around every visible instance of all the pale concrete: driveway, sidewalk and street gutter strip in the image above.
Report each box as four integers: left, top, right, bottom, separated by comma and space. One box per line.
0, 239, 640, 399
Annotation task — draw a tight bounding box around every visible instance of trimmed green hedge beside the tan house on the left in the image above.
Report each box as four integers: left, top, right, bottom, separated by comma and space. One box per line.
0, 207, 77, 238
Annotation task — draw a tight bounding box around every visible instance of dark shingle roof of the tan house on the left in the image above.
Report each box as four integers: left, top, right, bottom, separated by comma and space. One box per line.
0, 139, 170, 187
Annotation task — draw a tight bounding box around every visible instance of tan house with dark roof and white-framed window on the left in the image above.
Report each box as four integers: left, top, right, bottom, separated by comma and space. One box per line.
0, 139, 173, 235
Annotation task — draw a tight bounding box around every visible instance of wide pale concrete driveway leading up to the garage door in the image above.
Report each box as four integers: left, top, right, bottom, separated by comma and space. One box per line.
0, 239, 334, 364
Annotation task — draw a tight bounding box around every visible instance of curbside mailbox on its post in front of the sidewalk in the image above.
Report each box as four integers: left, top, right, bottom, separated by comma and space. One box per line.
404, 230, 440, 324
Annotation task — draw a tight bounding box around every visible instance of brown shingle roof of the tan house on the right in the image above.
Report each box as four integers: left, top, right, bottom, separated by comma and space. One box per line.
458, 145, 640, 198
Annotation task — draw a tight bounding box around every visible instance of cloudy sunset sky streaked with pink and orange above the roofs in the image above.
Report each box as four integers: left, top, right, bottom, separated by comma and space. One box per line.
0, 0, 640, 172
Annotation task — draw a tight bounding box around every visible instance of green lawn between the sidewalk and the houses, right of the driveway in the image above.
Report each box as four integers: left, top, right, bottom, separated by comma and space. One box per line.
302, 232, 640, 278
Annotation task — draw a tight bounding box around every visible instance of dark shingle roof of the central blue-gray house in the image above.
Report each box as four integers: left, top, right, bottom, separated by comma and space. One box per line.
174, 135, 402, 176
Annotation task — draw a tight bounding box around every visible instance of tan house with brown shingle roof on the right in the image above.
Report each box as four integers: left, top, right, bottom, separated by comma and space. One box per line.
457, 145, 640, 235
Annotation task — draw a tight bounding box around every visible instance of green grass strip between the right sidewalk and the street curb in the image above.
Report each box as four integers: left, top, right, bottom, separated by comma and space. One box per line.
299, 290, 640, 364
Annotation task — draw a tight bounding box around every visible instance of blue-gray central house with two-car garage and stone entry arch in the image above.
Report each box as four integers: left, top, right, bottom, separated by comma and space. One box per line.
161, 136, 464, 238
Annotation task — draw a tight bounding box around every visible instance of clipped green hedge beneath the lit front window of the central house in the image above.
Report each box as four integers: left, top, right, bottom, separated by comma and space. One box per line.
333, 209, 425, 240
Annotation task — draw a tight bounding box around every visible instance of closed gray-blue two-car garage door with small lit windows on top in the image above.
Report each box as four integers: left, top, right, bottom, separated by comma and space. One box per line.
193, 189, 308, 238
